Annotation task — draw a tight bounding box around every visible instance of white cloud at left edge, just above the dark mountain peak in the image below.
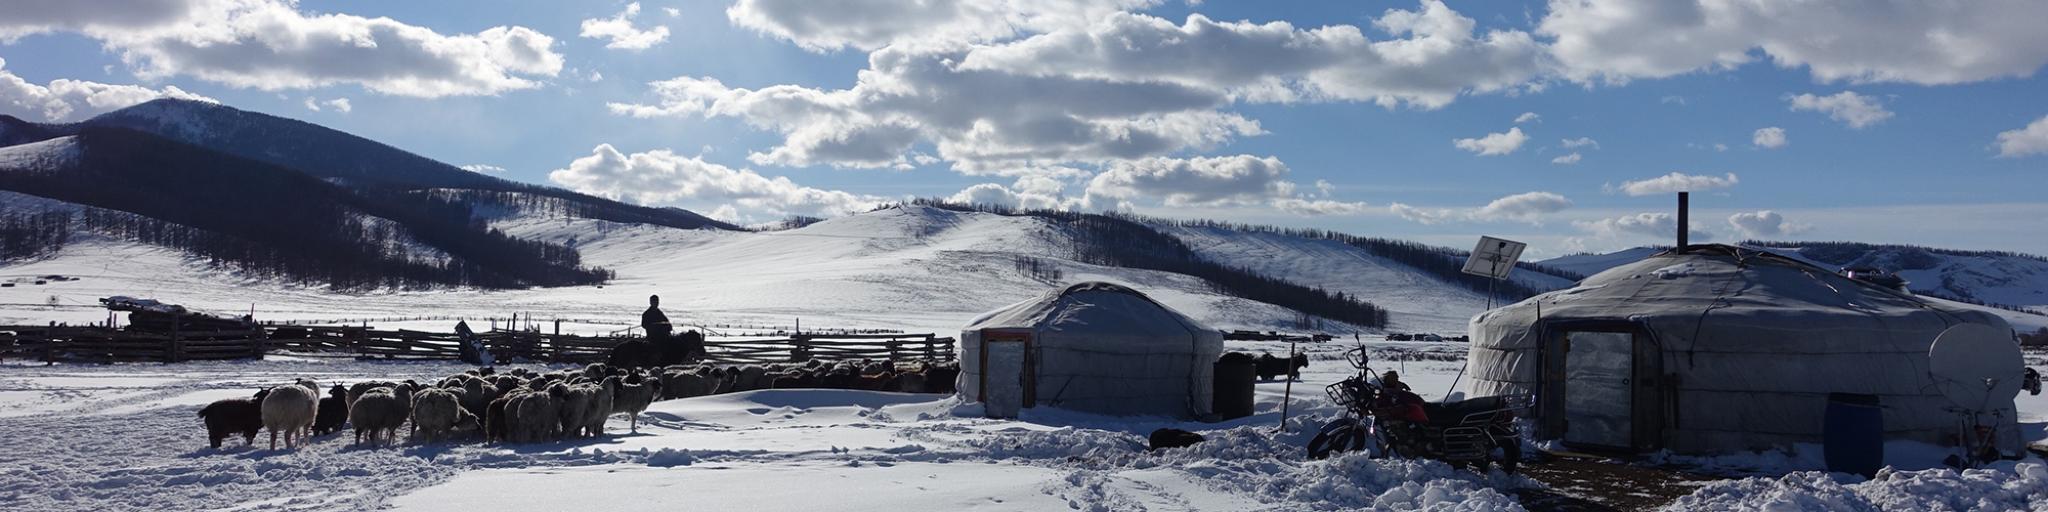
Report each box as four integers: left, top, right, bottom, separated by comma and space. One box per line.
0, 59, 217, 121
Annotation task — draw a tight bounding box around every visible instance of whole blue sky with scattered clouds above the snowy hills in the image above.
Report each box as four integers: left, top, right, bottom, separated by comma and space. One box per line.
0, 0, 2048, 256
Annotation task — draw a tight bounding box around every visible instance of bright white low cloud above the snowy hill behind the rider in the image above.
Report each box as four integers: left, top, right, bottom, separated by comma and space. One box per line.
547, 143, 889, 217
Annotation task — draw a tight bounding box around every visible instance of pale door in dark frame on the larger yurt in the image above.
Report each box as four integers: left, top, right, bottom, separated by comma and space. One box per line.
1563, 330, 1636, 449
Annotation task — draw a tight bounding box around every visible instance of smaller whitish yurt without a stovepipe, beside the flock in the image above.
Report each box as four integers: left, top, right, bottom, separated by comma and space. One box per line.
958, 283, 1223, 418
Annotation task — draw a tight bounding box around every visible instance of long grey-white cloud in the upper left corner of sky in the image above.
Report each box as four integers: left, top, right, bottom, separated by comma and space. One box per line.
0, 0, 561, 98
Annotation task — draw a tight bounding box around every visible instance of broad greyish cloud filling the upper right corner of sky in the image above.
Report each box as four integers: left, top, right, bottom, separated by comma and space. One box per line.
1536, 0, 2048, 86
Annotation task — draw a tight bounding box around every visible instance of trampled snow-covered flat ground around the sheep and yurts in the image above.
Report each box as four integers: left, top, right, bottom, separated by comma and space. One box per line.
0, 342, 2048, 510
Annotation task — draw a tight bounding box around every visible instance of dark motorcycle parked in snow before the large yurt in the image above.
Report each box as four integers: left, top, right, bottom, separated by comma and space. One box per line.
1309, 346, 1536, 473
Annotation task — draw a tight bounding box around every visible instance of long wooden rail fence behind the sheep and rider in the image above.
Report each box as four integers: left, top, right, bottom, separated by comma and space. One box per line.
0, 326, 956, 362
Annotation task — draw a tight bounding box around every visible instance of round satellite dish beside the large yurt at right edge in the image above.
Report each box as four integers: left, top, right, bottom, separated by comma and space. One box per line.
1927, 324, 2025, 412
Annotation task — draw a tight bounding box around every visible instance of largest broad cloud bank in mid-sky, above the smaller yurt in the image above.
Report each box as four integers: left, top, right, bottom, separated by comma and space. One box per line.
608, 47, 1264, 174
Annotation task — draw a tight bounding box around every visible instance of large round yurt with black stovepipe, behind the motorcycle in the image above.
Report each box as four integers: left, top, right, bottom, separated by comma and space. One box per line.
1466, 244, 2023, 453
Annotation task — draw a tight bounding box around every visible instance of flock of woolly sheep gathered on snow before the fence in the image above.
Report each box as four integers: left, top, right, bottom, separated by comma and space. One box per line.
199, 360, 961, 449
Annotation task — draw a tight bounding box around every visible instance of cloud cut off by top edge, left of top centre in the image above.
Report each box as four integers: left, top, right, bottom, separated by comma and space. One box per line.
725, 0, 1157, 51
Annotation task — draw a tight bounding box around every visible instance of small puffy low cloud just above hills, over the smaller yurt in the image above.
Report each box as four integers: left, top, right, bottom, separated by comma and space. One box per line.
1087, 156, 1294, 207
